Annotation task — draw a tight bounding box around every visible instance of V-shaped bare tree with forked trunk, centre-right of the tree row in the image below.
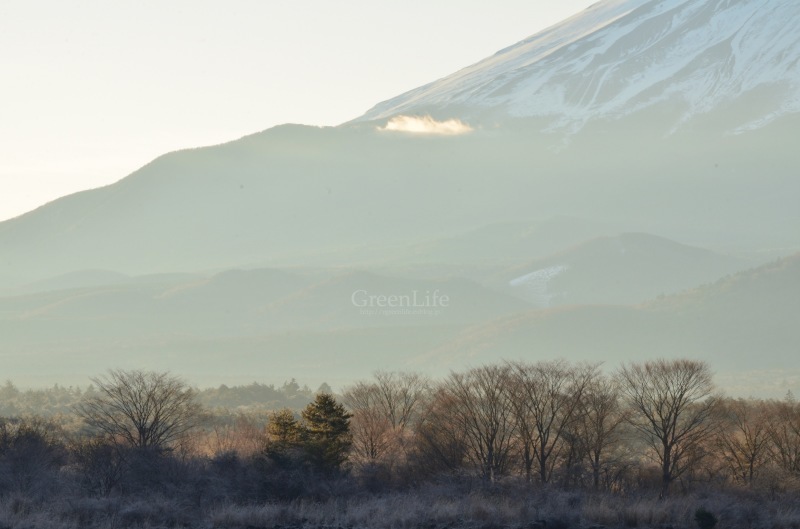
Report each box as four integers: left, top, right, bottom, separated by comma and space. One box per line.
508, 360, 597, 483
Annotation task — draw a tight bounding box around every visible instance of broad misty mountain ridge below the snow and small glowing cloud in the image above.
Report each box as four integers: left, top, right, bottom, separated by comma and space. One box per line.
0, 120, 800, 290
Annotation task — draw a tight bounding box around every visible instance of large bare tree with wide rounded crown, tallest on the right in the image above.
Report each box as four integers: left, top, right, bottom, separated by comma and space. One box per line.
619, 360, 719, 497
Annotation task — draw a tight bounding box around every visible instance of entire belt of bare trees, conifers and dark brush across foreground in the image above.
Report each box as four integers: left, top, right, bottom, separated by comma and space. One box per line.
0, 360, 800, 527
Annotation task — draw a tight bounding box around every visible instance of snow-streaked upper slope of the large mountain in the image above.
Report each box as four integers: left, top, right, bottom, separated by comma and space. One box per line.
359, 0, 800, 132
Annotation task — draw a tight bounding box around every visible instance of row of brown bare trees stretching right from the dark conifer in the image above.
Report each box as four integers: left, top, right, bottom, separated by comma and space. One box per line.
344, 359, 800, 497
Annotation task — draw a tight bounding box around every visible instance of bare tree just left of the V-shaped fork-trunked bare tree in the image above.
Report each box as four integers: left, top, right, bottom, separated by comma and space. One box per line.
443, 365, 516, 481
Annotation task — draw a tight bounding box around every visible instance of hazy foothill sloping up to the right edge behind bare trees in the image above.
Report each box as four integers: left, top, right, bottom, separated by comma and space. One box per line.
429, 254, 800, 371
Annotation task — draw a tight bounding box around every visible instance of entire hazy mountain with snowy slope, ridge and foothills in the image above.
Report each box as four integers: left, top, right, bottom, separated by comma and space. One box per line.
0, 0, 800, 394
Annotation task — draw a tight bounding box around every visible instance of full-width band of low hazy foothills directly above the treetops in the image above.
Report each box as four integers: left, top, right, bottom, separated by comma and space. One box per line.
0, 254, 800, 390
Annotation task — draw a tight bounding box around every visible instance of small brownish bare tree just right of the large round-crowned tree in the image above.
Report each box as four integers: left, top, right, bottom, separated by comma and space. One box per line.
715, 399, 770, 486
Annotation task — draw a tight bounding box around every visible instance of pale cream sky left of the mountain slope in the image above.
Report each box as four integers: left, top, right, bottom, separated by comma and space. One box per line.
0, 0, 595, 220
